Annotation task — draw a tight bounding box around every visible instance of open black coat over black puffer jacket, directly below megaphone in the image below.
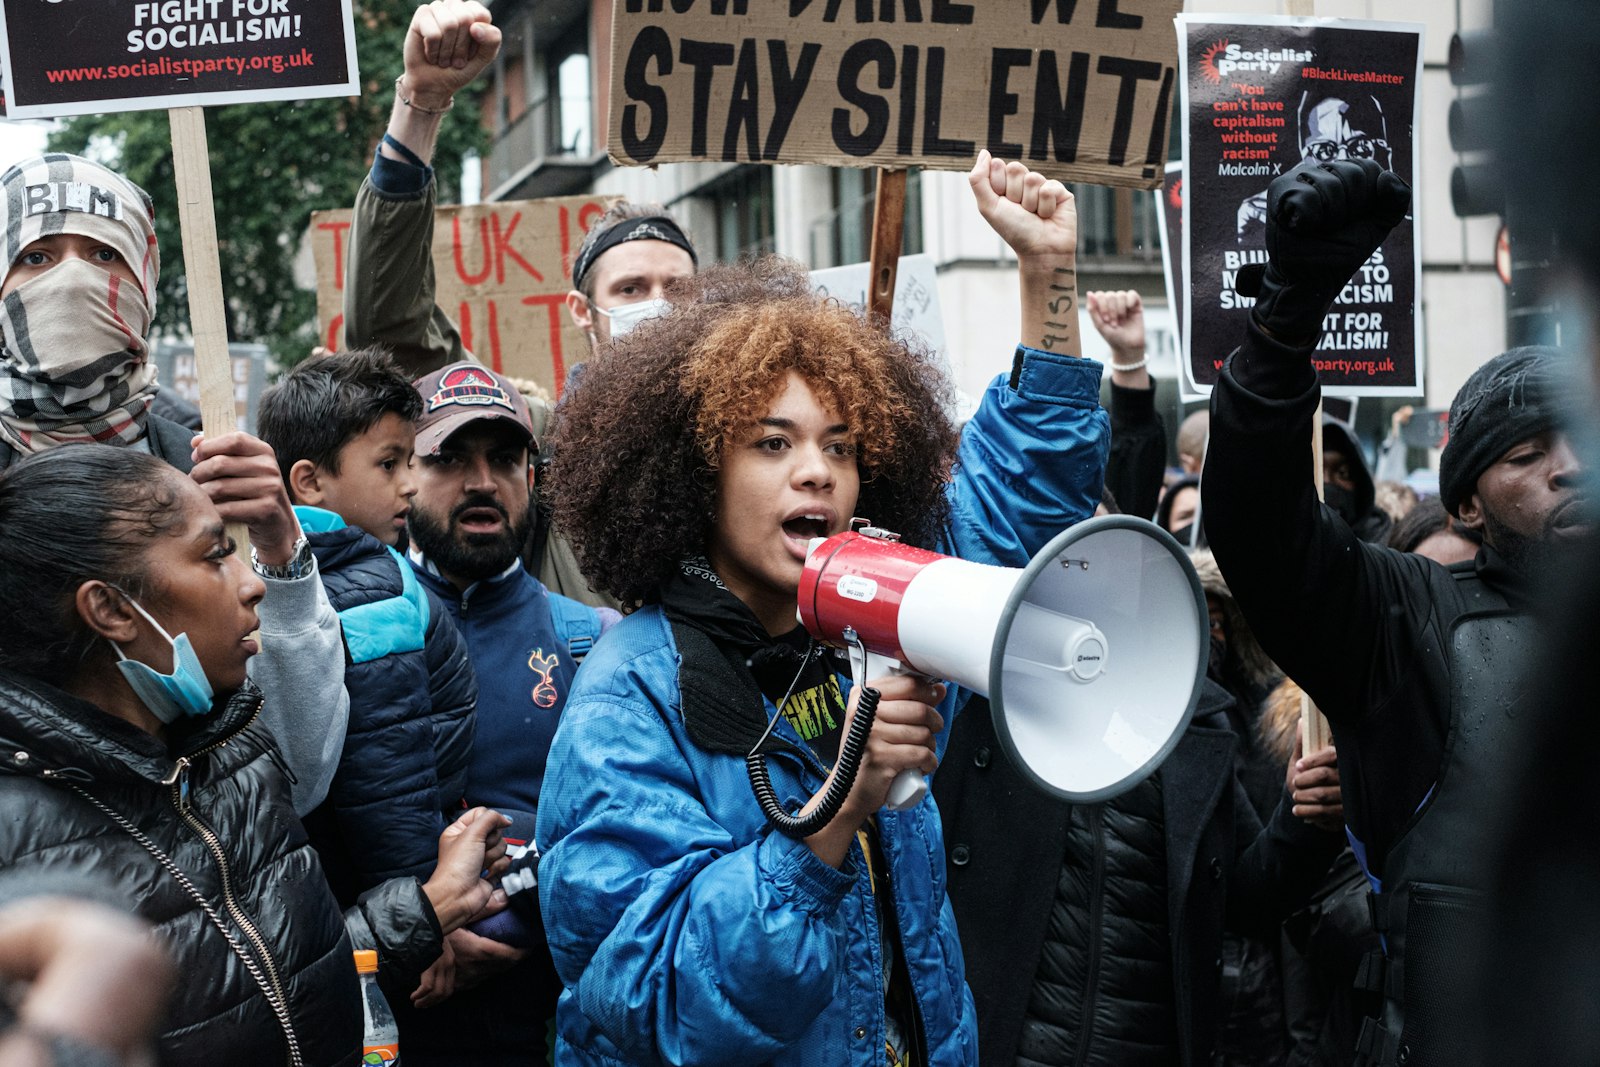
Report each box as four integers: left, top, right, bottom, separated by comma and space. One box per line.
933, 683, 1342, 1067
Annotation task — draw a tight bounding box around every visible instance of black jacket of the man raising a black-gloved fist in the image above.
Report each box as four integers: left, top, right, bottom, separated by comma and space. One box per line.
1205, 325, 1528, 875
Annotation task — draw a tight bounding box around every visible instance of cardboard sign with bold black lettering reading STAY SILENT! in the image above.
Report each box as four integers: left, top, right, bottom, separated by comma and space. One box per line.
610, 0, 1182, 189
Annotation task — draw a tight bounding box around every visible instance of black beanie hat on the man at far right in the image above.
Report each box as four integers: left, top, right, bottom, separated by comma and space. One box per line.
1438, 346, 1560, 515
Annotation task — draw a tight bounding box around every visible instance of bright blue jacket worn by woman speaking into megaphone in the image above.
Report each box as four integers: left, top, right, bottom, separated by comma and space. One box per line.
538, 349, 1109, 1067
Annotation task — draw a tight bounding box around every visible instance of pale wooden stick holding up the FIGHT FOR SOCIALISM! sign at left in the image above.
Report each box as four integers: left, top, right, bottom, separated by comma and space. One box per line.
166, 107, 250, 553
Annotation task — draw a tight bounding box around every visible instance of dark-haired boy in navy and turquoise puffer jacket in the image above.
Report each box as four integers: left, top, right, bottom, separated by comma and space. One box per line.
258, 350, 478, 927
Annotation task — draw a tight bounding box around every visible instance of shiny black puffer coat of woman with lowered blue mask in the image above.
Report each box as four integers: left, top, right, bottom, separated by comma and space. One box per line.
0, 670, 425, 1067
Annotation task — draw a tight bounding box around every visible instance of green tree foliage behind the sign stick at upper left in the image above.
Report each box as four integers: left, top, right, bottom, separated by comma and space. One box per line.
50, 0, 485, 365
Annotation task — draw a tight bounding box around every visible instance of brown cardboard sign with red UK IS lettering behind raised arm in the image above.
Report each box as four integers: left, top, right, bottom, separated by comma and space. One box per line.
309, 197, 611, 395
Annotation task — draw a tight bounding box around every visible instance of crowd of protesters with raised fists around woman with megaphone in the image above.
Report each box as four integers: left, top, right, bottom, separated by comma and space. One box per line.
0, 0, 1600, 1067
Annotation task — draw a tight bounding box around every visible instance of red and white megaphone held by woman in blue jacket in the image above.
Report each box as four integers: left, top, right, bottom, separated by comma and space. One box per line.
800, 515, 1210, 808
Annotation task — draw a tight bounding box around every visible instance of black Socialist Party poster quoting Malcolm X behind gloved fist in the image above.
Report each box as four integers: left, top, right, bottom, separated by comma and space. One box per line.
1178, 16, 1422, 397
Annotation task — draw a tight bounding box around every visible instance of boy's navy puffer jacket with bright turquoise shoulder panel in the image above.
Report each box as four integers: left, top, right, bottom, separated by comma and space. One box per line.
294, 507, 478, 905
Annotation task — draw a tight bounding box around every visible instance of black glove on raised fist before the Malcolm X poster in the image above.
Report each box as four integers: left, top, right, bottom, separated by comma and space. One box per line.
1237, 160, 1411, 344
